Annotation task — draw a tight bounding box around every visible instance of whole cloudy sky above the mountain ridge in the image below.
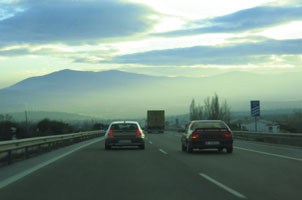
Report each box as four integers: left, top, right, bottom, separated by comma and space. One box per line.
0, 0, 302, 88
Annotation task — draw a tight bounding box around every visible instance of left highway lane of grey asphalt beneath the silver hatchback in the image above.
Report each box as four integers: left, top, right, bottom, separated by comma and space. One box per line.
0, 136, 238, 200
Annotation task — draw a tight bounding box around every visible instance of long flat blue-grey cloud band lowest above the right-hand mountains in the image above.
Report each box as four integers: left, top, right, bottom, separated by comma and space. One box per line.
108, 39, 302, 66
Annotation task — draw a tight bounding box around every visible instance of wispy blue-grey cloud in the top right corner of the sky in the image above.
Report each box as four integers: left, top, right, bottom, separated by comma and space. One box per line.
154, 6, 302, 37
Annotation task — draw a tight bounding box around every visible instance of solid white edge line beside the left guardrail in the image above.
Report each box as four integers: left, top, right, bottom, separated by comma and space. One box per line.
0, 137, 104, 189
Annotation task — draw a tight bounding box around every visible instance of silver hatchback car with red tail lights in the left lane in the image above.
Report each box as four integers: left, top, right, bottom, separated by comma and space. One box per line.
105, 121, 145, 150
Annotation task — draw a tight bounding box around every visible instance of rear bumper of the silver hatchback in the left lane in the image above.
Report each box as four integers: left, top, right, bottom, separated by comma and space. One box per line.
105, 138, 145, 146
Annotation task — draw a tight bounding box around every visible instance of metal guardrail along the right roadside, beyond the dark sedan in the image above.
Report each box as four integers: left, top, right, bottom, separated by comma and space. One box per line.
233, 131, 302, 147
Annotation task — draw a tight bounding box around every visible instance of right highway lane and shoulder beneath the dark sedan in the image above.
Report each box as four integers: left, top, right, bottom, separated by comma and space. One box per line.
149, 132, 302, 199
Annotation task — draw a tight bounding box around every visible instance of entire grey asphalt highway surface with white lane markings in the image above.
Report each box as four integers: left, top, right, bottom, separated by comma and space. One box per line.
0, 131, 302, 200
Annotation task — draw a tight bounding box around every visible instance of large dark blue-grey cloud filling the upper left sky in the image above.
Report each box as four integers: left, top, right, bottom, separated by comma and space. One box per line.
0, 0, 154, 46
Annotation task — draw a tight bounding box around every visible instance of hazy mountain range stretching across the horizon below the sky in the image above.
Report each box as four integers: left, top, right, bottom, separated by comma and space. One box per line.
0, 70, 302, 119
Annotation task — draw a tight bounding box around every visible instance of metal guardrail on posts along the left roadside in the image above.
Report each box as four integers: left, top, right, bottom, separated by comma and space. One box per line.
0, 131, 105, 163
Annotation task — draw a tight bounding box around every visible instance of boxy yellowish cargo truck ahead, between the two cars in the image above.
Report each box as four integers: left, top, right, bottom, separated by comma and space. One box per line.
147, 110, 165, 133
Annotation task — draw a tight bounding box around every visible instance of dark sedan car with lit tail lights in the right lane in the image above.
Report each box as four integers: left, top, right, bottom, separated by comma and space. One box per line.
181, 120, 233, 153
